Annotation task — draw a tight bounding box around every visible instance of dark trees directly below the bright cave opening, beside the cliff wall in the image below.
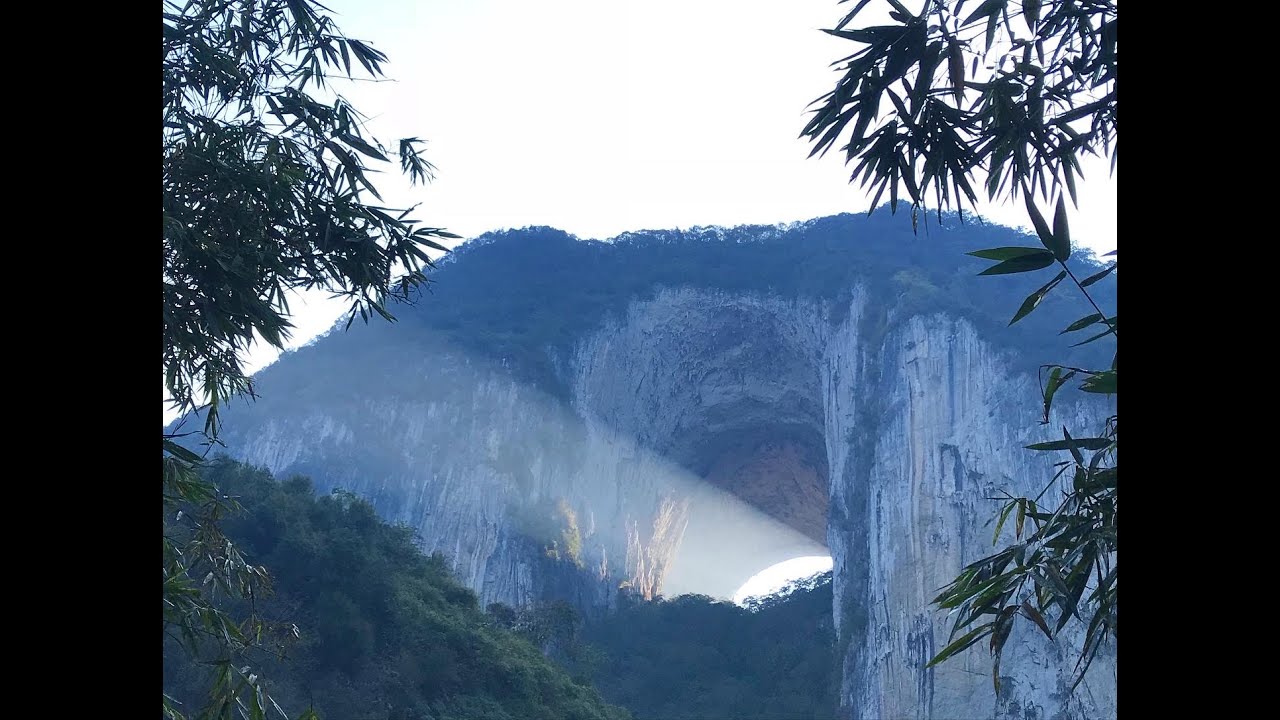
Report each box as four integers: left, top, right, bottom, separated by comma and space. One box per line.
556, 573, 840, 720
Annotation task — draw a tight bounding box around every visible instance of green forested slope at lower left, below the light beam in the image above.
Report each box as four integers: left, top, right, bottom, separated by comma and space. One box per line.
164, 459, 627, 720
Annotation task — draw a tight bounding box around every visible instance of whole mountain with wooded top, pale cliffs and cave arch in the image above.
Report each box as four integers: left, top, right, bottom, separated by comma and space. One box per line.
185, 211, 1116, 720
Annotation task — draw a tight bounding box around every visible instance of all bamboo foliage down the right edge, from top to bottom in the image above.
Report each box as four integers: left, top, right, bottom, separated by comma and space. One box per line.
803, 0, 1119, 693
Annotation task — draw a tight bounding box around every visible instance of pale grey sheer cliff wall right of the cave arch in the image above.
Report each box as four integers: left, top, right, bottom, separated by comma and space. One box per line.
832, 316, 1116, 719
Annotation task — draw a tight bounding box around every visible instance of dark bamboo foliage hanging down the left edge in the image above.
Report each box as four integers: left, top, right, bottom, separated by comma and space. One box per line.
161, 0, 456, 719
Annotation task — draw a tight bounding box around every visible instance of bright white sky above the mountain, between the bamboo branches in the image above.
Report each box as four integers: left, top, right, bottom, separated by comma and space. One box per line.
251, 0, 1116, 368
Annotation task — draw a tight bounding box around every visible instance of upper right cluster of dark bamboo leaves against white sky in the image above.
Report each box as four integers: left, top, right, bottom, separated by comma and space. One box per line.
801, 0, 1116, 219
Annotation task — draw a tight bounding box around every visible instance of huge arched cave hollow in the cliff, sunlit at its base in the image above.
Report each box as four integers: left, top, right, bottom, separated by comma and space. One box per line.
579, 288, 831, 600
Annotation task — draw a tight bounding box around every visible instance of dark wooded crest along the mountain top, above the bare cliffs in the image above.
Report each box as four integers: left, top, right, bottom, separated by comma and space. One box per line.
264, 213, 1115, 393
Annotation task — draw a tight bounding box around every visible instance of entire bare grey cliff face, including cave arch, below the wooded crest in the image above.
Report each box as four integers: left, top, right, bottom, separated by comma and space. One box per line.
207, 221, 1116, 720
